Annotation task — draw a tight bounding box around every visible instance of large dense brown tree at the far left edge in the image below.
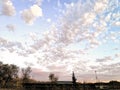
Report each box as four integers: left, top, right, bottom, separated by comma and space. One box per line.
0, 62, 19, 87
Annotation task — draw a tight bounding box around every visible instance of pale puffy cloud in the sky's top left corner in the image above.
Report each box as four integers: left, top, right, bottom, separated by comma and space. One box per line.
2, 0, 16, 16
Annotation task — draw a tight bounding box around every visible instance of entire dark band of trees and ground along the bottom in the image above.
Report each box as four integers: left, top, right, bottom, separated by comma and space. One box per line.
0, 62, 120, 90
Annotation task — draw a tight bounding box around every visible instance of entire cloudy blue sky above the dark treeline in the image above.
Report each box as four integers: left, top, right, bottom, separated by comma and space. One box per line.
0, 0, 120, 82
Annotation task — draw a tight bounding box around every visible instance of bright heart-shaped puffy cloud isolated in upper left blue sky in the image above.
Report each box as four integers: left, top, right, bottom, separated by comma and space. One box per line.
21, 4, 42, 24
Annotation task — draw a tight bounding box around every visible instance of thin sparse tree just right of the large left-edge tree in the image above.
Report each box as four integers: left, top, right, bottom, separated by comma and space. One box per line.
22, 67, 32, 83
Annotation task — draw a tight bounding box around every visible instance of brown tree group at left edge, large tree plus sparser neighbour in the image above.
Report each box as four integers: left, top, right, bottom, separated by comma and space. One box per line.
0, 62, 35, 88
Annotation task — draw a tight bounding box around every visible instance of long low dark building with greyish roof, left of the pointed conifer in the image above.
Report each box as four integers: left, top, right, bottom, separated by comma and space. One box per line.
23, 81, 80, 90
